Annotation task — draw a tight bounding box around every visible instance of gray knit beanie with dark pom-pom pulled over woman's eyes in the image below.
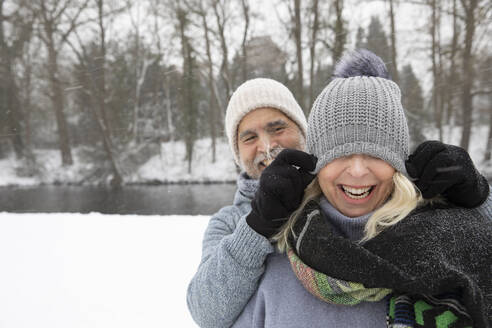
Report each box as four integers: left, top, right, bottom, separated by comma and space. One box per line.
307, 50, 409, 174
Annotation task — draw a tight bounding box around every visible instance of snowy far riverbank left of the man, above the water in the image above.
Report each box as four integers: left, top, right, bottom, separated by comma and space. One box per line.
0, 138, 237, 186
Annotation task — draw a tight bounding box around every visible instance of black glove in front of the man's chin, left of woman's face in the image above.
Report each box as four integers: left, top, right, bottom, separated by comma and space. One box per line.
246, 149, 317, 238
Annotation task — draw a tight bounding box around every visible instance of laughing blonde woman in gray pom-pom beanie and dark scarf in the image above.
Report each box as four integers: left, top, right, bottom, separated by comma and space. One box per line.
235, 51, 492, 327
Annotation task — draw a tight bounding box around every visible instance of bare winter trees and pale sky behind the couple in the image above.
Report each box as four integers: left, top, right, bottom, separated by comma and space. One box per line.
0, 0, 492, 186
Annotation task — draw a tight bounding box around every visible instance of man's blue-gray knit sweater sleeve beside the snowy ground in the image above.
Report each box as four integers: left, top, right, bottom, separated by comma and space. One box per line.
187, 206, 274, 328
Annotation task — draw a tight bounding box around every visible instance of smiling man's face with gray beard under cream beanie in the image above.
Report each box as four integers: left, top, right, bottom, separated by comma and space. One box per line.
237, 108, 305, 179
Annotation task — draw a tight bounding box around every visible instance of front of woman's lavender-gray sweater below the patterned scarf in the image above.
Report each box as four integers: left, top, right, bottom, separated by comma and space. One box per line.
232, 253, 387, 328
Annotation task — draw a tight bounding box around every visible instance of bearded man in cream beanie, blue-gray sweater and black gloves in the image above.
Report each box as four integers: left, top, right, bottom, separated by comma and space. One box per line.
187, 79, 492, 328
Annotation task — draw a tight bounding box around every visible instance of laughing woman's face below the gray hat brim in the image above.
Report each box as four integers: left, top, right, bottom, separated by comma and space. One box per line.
318, 154, 395, 217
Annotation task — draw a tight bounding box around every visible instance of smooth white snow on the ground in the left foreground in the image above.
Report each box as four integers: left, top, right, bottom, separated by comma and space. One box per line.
0, 213, 208, 328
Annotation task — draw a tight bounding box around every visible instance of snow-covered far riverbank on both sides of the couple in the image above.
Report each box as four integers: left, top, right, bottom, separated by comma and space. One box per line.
0, 125, 492, 186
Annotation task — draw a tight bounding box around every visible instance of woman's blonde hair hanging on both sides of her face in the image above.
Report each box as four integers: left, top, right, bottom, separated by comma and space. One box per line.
273, 172, 423, 252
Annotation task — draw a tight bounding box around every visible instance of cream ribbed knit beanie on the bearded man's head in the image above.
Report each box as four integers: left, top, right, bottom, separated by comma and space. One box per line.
225, 78, 307, 165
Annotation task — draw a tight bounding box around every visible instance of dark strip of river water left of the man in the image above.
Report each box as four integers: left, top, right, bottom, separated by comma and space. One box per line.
0, 184, 236, 215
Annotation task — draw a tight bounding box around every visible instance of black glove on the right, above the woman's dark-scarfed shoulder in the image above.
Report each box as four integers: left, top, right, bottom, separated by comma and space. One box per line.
405, 141, 489, 208
